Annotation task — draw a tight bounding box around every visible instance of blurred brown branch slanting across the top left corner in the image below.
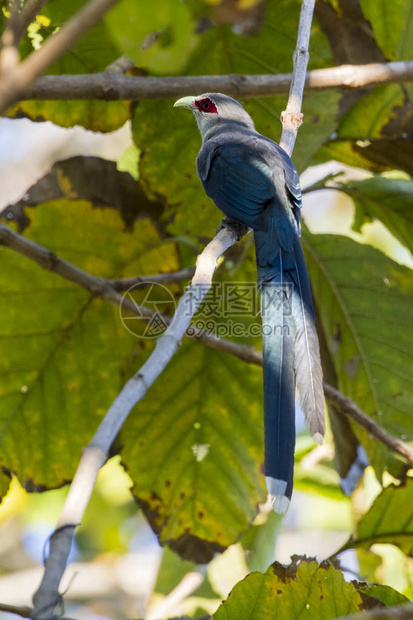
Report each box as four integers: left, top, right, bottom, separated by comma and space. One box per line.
0, 0, 118, 114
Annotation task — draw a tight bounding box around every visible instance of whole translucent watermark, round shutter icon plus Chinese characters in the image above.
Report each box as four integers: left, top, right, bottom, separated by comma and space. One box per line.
119, 281, 292, 339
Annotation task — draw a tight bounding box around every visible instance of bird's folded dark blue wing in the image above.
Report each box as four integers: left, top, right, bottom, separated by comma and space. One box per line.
197, 140, 276, 229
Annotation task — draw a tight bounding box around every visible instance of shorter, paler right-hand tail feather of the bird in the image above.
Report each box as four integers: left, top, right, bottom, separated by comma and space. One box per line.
292, 237, 324, 443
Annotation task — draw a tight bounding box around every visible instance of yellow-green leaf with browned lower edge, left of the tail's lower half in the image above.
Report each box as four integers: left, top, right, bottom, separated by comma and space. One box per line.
121, 342, 266, 563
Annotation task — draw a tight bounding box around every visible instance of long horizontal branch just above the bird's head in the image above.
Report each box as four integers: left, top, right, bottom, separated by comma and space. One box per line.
8, 60, 413, 101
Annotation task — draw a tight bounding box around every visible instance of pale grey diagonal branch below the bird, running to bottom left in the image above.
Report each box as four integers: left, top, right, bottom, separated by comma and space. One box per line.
33, 228, 238, 620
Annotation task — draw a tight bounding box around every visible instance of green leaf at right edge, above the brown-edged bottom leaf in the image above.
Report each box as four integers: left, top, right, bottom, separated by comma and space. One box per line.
340, 478, 413, 556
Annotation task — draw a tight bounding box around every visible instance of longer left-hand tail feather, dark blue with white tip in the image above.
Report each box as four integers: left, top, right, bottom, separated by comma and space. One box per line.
261, 249, 295, 514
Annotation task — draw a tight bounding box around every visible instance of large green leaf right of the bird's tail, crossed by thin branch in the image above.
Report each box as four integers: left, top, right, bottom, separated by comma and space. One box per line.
303, 234, 413, 479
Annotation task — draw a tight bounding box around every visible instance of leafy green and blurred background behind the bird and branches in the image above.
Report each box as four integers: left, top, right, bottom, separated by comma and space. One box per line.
0, 0, 413, 620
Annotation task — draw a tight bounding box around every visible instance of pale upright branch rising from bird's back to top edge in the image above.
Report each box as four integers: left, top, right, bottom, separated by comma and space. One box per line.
280, 0, 315, 156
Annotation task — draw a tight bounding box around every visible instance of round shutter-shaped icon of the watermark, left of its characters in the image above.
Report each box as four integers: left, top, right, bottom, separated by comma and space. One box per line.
119, 281, 176, 340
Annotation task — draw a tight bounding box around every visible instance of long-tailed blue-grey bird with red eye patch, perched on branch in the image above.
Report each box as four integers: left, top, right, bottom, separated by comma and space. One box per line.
174, 93, 324, 514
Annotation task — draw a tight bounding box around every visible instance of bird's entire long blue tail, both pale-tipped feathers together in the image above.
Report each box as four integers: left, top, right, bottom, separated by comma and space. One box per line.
255, 231, 324, 514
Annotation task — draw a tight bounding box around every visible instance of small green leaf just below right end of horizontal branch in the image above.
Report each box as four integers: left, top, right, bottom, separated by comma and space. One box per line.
337, 84, 405, 140
